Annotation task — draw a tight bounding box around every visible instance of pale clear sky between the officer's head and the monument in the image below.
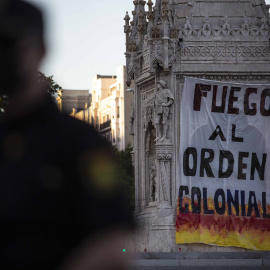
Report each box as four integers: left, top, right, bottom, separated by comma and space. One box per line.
28, 0, 270, 90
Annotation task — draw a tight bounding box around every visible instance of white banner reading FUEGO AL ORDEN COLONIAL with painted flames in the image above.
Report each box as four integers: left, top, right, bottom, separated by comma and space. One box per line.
176, 78, 270, 250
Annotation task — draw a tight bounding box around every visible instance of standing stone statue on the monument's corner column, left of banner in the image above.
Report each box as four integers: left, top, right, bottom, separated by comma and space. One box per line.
155, 80, 174, 142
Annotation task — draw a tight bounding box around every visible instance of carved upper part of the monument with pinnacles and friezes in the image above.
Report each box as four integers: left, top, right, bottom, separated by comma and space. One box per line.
125, 0, 270, 80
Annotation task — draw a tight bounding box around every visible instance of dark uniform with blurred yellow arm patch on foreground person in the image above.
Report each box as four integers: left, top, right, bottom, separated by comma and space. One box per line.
0, 97, 131, 270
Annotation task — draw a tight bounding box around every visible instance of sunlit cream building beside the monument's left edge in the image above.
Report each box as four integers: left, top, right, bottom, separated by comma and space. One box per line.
71, 66, 133, 150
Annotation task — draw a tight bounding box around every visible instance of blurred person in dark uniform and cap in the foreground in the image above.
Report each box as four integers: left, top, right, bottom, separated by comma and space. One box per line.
0, 0, 132, 270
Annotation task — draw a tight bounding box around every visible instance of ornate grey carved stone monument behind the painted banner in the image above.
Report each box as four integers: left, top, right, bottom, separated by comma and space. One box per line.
124, 0, 270, 252
